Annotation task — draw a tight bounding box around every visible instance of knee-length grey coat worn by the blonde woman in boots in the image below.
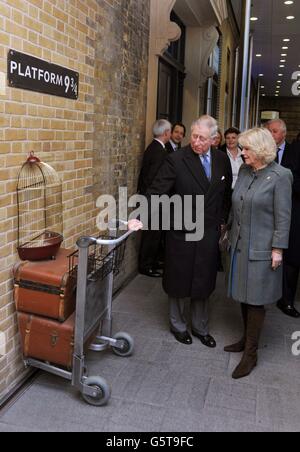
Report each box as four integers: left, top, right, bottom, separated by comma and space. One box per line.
229, 162, 293, 306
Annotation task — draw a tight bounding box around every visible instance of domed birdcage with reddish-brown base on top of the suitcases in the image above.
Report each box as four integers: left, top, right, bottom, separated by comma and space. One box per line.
17, 153, 63, 261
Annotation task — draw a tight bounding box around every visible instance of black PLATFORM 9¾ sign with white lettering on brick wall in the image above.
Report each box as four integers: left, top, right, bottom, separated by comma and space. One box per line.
7, 50, 79, 100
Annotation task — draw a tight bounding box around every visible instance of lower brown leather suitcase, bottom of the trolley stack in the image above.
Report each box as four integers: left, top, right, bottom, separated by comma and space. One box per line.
18, 313, 75, 369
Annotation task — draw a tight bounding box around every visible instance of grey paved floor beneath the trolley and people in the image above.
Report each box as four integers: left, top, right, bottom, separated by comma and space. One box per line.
0, 275, 300, 432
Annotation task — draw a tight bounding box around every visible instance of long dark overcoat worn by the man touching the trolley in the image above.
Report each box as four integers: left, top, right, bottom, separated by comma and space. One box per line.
147, 146, 232, 300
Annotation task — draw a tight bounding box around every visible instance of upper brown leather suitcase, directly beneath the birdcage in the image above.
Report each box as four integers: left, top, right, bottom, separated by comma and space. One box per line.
14, 249, 76, 322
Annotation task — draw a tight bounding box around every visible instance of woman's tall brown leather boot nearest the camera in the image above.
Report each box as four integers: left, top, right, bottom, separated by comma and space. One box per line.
232, 306, 266, 380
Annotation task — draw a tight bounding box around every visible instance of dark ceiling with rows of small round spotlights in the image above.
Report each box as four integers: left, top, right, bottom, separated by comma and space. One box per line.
232, 0, 300, 97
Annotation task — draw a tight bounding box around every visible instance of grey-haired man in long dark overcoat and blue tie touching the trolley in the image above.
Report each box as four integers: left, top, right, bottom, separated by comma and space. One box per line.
147, 116, 232, 348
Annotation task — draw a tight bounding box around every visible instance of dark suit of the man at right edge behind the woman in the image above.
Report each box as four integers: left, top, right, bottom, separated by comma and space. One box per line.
281, 143, 300, 306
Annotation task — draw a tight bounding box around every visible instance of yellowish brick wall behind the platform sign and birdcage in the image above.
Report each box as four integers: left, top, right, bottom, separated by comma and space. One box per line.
0, 0, 149, 399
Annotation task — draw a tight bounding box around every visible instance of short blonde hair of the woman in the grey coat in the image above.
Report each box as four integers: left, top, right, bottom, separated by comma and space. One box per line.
239, 128, 277, 165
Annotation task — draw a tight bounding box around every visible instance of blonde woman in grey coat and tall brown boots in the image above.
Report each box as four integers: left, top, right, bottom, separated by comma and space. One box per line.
225, 129, 293, 379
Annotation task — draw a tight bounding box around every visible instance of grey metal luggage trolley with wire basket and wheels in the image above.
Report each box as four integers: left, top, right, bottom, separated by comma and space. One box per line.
25, 221, 134, 406
